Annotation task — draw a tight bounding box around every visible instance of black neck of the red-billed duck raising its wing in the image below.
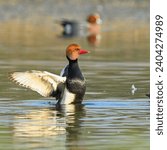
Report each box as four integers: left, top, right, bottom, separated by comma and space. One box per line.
68, 58, 84, 80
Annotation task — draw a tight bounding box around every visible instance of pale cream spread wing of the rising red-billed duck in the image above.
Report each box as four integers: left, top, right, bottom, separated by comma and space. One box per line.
10, 70, 66, 97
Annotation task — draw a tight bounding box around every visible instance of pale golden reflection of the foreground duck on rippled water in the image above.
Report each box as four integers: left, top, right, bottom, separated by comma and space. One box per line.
13, 104, 85, 139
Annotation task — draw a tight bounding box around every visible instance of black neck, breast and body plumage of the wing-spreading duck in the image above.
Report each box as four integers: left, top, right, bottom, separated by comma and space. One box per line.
54, 57, 86, 103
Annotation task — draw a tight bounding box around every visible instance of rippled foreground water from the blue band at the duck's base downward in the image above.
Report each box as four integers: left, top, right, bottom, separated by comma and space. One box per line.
0, 99, 149, 149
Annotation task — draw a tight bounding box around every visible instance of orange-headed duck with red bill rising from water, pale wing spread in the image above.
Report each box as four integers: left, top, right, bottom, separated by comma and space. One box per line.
9, 44, 89, 105
